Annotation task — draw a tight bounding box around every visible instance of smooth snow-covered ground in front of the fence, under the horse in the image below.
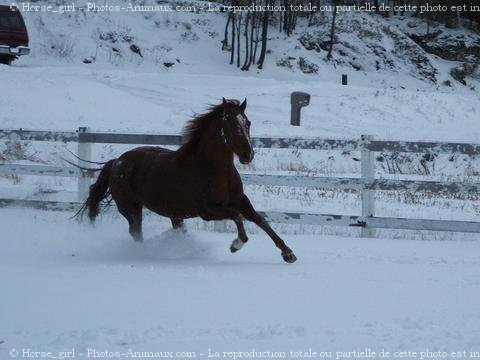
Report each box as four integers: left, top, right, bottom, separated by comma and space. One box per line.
0, 210, 480, 359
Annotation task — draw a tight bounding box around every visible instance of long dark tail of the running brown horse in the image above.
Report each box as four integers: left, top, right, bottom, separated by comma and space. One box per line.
77, 159, 115, 222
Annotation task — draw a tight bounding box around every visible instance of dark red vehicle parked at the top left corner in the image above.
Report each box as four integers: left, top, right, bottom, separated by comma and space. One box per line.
0, 5, 30, 65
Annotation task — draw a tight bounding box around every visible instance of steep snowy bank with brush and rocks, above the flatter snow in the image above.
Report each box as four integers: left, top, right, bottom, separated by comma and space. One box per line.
11, 1, 480, 82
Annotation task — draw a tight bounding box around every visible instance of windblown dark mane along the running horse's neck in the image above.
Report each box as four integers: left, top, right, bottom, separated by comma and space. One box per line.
181, 100, 240, 151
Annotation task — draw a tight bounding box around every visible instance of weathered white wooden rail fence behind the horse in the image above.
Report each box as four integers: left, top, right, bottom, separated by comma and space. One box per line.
0, 128, 480, 237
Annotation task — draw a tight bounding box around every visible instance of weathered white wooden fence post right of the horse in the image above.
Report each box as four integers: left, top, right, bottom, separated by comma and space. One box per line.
361, 135, 375, 237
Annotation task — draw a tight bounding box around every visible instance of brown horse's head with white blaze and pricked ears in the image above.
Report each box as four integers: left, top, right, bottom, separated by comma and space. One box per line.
221, 98, 255, 164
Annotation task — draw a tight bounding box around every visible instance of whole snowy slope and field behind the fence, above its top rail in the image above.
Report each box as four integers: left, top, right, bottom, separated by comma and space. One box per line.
0, 2, 480, 135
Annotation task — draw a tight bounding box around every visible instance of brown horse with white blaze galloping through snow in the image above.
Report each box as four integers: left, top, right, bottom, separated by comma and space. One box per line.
84, 99, 297, 263
